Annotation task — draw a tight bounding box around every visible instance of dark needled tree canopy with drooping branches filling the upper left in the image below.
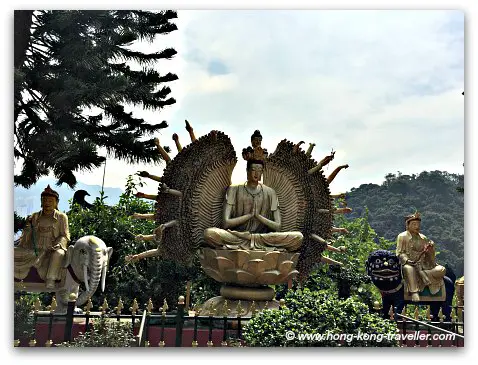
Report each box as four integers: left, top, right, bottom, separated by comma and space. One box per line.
14, 10, 178, 188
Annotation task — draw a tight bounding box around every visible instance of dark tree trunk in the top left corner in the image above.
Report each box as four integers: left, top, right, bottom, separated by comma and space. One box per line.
13, 10, 33, 68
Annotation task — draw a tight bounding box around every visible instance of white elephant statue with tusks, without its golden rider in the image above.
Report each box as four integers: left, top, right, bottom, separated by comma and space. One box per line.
15, 236, 113, 313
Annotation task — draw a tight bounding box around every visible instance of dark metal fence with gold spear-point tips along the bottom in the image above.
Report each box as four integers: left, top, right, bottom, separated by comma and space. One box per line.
14, 296, 464, 347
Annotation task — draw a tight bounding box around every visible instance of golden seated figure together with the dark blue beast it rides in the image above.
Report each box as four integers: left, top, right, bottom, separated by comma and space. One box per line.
367, 212, 456, 320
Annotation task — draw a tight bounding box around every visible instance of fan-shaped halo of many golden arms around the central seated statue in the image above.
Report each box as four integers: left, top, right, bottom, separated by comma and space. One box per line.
127, 121, 351, 280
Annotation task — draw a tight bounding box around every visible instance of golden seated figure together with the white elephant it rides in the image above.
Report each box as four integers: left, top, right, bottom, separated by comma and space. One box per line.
14, 186, 113, 313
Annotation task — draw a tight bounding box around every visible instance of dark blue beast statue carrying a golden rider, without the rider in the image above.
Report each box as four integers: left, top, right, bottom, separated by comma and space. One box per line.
365, 250, 456, 321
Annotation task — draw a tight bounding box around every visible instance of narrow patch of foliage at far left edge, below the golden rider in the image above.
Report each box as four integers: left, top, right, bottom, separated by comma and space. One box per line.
13, 294, 38, 340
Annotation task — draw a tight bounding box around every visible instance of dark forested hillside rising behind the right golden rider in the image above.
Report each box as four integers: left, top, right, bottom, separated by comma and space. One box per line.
347, 171, 465, 276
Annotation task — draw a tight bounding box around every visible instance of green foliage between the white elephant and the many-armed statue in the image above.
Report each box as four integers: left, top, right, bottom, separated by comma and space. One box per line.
68, 176, 198, 308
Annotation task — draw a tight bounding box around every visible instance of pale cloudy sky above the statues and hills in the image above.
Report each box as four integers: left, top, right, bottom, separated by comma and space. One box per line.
72, 10, 465, 193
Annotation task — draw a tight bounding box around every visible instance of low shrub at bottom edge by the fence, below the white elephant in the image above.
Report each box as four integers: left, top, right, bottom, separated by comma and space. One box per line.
56, 316, 135, 347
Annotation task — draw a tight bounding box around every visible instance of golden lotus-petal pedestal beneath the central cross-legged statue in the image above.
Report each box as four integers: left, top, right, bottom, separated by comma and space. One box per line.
199, 248, 299, 317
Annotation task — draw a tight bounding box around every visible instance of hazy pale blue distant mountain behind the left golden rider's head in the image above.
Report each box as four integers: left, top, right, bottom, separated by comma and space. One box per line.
13, 178, 123, 217
